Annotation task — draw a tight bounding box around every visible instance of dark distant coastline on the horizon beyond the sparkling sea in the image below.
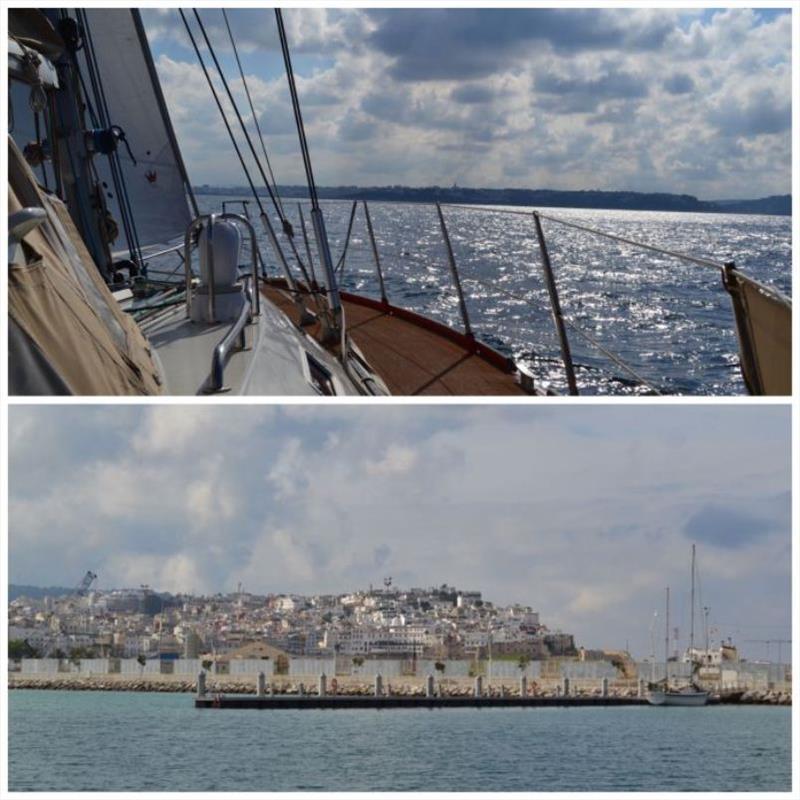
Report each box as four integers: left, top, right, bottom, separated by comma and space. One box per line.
194, 184, 792, 216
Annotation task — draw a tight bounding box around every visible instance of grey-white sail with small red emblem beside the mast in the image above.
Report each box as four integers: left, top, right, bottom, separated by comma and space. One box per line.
79, 8, 193, 251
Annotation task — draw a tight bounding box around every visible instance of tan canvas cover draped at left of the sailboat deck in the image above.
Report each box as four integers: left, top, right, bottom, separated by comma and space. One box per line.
8, 136, 162, 395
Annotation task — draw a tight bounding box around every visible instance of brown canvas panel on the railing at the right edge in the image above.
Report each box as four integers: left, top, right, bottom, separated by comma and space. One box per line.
726, 270, 792, 395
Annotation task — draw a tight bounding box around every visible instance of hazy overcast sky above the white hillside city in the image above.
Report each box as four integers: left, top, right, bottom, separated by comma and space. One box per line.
9, 404, 791, 656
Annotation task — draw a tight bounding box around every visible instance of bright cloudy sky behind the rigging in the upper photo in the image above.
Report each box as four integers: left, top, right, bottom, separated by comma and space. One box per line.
143, 7, 791, 199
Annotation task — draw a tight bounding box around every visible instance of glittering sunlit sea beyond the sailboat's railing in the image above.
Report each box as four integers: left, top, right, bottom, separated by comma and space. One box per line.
192, 196, 791, 394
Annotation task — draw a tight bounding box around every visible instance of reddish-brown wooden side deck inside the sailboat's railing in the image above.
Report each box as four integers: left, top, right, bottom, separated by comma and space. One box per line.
262, 281, 525, 396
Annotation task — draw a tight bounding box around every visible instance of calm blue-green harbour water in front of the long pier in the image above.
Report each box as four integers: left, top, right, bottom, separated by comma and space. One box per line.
8, 691, 791, 791
